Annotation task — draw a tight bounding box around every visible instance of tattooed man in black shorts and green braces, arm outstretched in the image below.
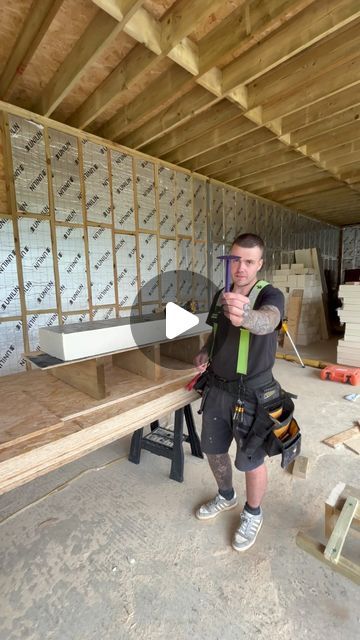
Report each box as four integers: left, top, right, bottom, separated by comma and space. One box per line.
195, 233, 284, 551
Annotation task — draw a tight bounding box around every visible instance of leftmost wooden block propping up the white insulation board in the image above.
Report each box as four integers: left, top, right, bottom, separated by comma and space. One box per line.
49, 360, 106, 400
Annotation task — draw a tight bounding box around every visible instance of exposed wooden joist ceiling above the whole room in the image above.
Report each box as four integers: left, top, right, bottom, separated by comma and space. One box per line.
0, 0, 360, 225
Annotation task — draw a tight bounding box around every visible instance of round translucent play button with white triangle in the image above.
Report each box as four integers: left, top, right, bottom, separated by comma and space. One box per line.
126, 268, 217, 370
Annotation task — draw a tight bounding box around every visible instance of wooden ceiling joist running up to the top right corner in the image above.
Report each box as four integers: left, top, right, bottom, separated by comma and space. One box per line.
224, 0, 360, 92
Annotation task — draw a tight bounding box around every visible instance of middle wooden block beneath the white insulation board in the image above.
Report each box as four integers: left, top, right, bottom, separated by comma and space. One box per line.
112, 344, 161, 380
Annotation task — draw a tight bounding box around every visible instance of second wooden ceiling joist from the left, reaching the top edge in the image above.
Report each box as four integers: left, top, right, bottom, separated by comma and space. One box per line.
33, 0, 140, 116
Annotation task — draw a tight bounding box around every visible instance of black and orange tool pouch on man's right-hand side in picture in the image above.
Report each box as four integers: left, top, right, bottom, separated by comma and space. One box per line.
264, 394, 301, 469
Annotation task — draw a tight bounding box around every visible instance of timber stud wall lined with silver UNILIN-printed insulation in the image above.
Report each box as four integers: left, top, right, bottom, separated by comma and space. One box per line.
0, 103, 340, 374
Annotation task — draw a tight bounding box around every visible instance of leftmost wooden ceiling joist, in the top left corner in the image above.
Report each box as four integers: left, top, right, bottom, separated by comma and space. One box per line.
0, 0, 63, 99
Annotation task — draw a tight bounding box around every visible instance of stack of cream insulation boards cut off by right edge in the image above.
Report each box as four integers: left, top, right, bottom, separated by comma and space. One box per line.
337, 283, 360, 367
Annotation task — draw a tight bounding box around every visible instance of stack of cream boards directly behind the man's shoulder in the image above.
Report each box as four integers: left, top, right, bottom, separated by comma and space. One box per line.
272, 263, 323, 346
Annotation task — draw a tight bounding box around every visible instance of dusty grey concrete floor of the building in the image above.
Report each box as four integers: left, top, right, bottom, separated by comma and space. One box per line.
0, 350, 360, 640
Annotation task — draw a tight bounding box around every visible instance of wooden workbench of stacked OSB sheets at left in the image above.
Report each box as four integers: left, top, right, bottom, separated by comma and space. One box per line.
0, 356, 198, 494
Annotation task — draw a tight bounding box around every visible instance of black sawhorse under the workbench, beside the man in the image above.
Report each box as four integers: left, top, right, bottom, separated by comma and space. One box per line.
128, 404, 204, 482
